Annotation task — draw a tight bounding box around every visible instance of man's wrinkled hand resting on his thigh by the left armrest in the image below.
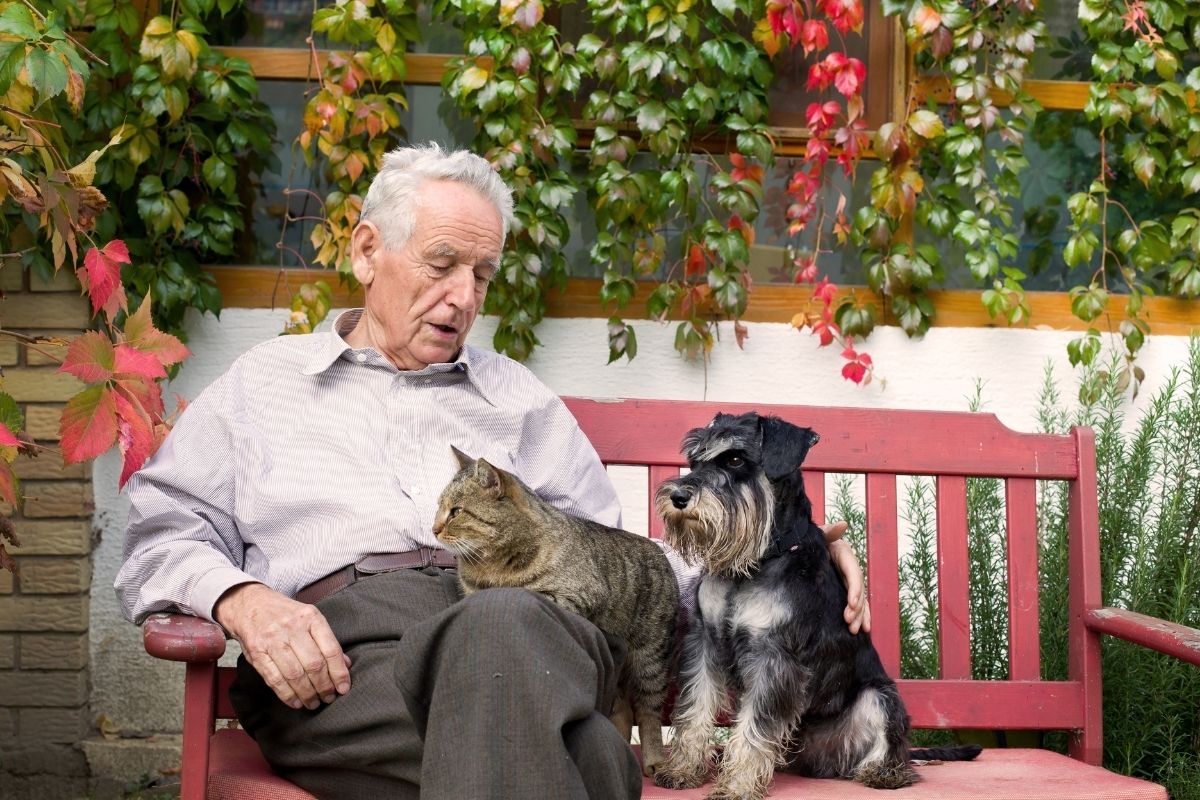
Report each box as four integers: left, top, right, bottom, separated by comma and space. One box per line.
212, 583, 350, 710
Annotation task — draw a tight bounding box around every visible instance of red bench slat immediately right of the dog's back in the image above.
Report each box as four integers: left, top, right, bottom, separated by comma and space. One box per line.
866, 474, 900, 678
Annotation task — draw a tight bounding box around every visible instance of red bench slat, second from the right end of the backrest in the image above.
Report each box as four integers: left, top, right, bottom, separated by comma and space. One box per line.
937, 475, 971, 679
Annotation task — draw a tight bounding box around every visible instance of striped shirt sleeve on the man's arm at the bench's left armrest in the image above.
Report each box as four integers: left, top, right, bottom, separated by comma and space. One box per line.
114, 375, 256, 624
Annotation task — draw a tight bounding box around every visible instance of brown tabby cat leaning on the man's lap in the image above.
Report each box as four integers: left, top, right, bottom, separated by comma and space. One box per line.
433, 449, 679, 776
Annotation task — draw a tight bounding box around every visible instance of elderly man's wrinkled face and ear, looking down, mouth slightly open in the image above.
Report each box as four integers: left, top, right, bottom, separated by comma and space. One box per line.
347, 181, 503, 369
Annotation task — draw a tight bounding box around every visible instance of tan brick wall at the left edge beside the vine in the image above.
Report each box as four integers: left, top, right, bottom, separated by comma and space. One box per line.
0, 265, 92, 800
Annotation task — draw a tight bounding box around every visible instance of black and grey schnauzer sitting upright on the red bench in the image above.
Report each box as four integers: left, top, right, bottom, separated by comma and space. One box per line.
655, 413, 979, 800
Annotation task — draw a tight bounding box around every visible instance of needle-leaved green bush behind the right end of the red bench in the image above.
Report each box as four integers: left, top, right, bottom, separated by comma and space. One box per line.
900, 338, 1200, 800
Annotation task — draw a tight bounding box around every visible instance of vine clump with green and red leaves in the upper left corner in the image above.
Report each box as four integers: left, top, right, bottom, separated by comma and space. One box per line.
0, 0, 274, 570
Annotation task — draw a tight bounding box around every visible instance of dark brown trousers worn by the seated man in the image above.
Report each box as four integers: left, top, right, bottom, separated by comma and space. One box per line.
230, 567, 641, 800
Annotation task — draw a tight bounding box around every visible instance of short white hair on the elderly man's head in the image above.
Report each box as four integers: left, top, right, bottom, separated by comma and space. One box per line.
360, 142, 512, 251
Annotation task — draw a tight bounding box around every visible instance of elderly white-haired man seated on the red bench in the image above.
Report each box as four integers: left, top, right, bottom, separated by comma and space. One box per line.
116, 145, 865, 800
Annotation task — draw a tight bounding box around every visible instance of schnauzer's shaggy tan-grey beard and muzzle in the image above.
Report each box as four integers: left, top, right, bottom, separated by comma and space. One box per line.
654, 475, 775, 576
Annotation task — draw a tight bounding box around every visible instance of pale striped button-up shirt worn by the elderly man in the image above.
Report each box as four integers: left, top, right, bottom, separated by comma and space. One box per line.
115, 309, 620, 622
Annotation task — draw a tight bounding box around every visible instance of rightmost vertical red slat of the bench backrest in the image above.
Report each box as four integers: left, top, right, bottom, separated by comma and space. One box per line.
1004, 477, 1042, 680
